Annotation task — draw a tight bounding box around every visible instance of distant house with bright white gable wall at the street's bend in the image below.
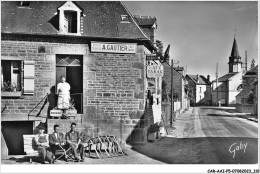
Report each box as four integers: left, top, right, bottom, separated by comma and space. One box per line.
186, 74, 211, 106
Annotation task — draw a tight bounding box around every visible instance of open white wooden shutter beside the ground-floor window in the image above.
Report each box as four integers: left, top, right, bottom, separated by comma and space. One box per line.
24, 61, 35, 94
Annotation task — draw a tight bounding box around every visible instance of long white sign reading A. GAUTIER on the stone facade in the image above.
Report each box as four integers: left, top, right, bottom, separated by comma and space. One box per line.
91, 42, 137, 53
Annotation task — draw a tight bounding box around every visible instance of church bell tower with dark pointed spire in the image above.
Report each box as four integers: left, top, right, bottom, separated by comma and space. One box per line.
228, 36, 242, 73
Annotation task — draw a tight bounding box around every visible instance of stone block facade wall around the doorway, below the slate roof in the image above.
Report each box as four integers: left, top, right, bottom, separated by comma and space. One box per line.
1, 36, 149, 144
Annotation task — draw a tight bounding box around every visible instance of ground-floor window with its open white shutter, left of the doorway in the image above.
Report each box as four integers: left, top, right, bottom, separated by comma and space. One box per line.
1, 60, 34, 97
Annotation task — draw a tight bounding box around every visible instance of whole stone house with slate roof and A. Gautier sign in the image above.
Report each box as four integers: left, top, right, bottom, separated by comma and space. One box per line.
1, 1, 158, 155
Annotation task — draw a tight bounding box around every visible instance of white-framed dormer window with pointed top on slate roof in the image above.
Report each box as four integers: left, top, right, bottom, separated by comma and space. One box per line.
58, 1, 82, 35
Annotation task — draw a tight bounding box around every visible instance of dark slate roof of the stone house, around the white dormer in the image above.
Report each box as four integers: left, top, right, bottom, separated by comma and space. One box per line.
1, 1, 148, 40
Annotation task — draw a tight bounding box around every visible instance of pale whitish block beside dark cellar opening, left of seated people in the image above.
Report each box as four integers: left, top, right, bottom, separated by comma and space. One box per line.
23, 135, 39, 162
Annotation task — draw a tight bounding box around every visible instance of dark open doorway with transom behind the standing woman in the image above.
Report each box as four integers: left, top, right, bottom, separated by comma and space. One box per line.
56, 55, 83, 114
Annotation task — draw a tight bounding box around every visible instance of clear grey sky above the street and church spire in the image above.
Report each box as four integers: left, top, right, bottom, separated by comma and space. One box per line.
123, 1, 258, 80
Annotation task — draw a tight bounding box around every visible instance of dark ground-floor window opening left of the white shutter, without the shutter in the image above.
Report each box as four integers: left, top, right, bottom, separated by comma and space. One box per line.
1, 60, 21, 92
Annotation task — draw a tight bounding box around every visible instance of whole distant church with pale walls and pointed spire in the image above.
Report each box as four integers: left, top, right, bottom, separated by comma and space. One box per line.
212, 38, 243, 106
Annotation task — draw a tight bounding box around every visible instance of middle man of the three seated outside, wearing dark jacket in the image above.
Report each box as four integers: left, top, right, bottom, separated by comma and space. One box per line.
49, 124, 67, 161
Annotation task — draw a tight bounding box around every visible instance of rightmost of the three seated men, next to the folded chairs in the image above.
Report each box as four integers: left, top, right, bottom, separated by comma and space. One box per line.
65, 123, 85, 162
